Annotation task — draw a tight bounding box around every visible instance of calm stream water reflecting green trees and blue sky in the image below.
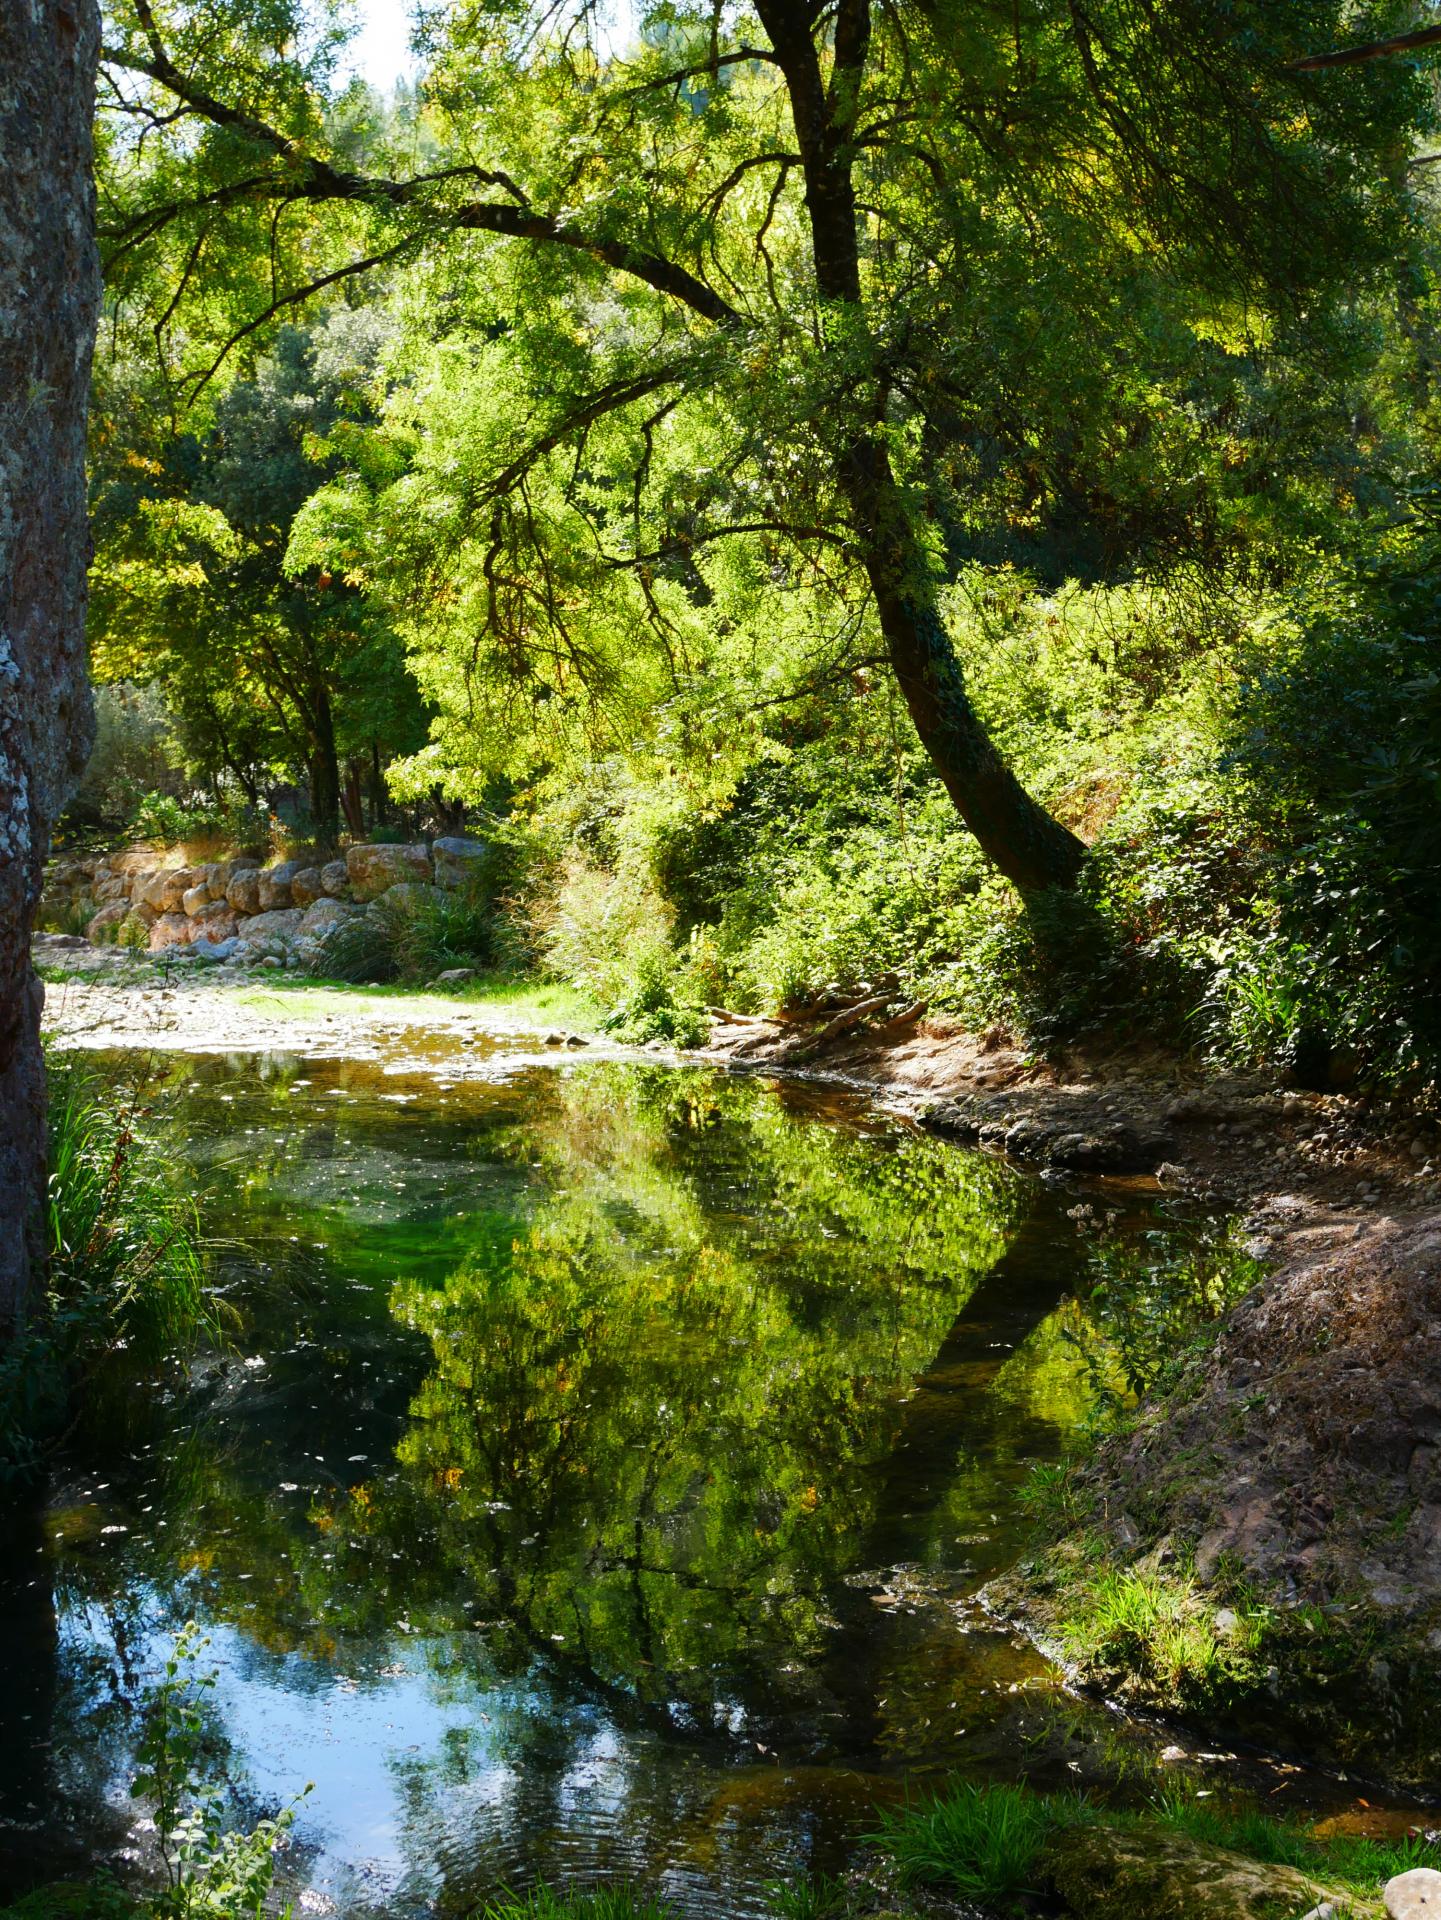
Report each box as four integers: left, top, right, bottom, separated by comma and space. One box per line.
0, 1056, 1281, 1916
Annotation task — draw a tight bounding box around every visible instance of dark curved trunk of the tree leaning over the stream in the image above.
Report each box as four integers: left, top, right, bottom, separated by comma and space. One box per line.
756, 0, 1086, 893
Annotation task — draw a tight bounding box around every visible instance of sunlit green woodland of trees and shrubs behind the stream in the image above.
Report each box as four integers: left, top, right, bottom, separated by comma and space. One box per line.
76, 0, 1441, 1085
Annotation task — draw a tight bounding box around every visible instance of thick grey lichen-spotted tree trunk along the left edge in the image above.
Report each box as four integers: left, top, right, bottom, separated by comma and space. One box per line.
0, 0, 100, 1338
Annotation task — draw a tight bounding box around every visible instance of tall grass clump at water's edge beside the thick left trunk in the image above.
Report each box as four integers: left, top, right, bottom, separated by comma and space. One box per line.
0, 1062, 215, 1478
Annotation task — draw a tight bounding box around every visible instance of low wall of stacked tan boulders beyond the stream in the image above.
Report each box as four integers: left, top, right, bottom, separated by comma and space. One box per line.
46, 839, 485, 966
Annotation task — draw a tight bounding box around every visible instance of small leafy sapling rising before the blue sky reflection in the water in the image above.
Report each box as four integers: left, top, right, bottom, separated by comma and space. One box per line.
130, 1622, 311, 1920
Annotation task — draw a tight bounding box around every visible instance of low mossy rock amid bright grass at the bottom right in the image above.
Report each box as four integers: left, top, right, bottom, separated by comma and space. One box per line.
1040, 1826, 1373, 1920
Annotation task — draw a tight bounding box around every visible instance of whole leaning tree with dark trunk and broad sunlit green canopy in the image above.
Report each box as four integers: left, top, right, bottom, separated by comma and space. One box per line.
102, 0, 1429, 891
